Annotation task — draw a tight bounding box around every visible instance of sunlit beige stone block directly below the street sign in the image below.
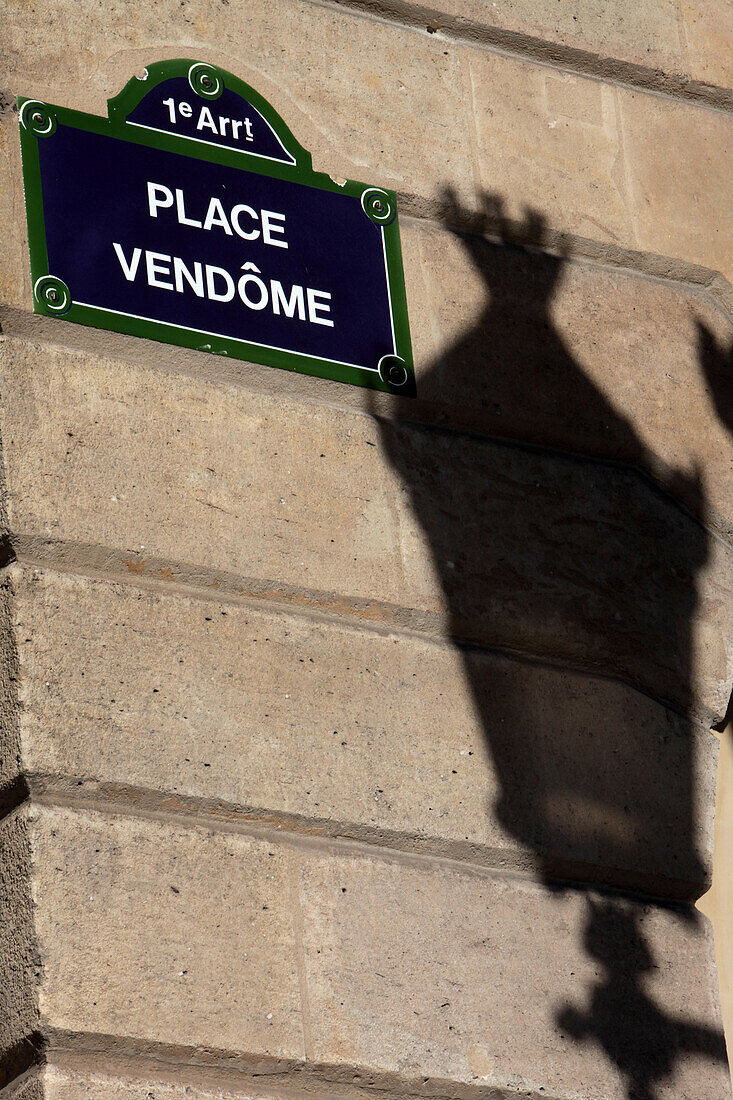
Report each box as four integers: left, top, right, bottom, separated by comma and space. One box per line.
3, 345, 405, 602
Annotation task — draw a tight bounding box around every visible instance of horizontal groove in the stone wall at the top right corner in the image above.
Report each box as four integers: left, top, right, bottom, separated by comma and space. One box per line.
317, 0, 733, 112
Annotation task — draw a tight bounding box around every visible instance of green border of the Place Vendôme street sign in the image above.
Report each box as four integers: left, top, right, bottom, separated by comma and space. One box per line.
18, 58, 415, 396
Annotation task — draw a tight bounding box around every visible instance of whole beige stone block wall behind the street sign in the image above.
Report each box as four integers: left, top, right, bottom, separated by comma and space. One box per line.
0, 0, 733, 1100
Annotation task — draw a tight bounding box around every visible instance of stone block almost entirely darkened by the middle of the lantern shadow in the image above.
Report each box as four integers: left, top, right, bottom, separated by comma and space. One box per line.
382, 415, 733, 711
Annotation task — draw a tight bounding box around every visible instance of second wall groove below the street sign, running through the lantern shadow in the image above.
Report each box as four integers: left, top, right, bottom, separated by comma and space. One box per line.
7, 535, 710, 728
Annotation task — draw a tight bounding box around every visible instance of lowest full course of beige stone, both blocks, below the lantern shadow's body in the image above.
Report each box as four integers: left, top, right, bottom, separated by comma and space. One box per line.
18, 807, 730, 1100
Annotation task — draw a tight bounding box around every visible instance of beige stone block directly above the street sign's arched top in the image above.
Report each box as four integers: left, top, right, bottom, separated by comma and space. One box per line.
6, 0, 472, 202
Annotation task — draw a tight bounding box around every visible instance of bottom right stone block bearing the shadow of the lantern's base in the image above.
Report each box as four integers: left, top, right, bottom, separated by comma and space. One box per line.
302, 856, 731, 1100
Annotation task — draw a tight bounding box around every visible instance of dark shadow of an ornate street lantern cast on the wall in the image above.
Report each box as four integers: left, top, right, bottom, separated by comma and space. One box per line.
367, 194, 731, 1100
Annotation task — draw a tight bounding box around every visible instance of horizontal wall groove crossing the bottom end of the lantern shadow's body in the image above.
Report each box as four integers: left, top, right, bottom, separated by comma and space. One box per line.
28, 774, 707, 908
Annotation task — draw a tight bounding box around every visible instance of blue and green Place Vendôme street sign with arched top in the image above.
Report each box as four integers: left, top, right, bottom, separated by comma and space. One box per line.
18, 61, 415, 395
